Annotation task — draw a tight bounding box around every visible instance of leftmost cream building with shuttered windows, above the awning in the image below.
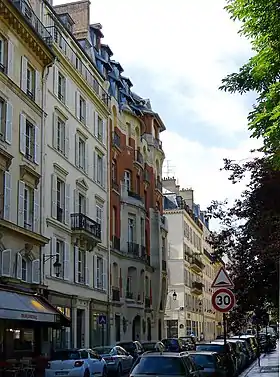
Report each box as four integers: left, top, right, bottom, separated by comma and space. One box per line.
0, 0, 54, 288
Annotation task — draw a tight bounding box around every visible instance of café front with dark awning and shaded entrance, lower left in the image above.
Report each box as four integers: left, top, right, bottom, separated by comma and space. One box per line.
0, 290, 70, 360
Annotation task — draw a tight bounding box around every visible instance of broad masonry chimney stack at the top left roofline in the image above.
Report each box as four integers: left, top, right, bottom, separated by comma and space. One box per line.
54, 0, 90, 39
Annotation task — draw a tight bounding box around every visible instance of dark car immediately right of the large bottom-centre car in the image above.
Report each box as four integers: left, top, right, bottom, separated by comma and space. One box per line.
189, 351, 227, 377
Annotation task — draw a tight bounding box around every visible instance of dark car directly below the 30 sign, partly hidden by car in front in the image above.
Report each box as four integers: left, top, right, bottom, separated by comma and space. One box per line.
196, 340, 237, 377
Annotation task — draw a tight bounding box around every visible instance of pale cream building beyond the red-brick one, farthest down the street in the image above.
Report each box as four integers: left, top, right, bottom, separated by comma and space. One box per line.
163, 178, 220, 340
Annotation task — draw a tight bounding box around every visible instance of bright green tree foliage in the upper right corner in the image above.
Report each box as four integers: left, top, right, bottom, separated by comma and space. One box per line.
220, 0, 280, 167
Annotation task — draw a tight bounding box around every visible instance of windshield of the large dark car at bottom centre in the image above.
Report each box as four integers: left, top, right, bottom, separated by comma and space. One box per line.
131, 356, 186, 376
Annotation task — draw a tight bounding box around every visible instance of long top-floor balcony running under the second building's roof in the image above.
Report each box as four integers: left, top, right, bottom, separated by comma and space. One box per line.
47, 26, 110, 107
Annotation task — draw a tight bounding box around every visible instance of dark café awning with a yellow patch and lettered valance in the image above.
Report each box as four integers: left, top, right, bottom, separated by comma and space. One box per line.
0, 291, 68, 324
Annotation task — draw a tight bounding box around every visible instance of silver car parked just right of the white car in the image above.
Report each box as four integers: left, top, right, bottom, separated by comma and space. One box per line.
94, 346, 133, 376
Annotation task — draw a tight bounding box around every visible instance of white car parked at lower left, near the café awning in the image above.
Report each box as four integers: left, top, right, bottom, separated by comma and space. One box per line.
45, 349, 107, 377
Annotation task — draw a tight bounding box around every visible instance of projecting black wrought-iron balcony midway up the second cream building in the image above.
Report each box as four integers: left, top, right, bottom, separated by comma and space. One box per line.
71, 213, 101, 251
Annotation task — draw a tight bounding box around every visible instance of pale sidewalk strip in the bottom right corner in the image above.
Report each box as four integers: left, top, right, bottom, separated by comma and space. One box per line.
240, 345, 279, 377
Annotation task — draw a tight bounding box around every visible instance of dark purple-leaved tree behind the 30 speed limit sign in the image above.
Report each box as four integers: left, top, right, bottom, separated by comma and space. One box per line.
208, 154, 280, 313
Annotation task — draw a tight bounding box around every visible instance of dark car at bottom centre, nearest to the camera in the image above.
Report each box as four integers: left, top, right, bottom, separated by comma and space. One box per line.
130, 352, 201, 377
